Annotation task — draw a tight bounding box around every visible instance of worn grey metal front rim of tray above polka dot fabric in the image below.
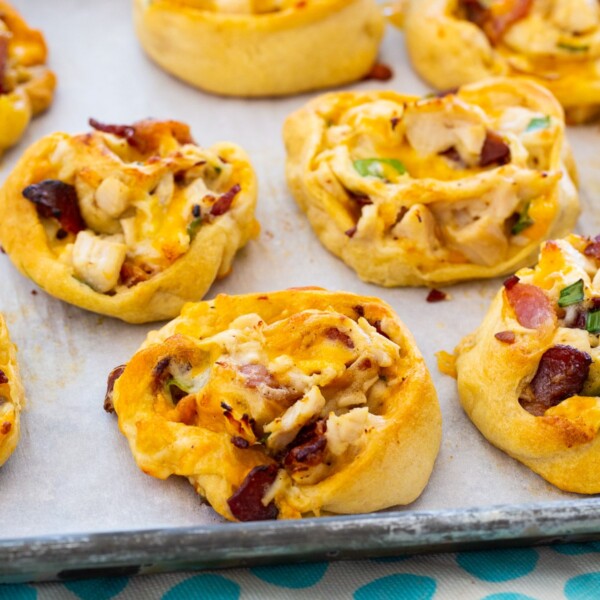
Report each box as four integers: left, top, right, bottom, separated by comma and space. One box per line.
0, 497, 600, 583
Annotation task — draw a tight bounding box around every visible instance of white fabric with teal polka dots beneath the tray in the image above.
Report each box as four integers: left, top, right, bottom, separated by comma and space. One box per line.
7, 542, 600, 600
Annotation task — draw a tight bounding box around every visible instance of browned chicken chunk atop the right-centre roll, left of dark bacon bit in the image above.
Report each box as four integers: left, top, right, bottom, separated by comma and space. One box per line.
404, 103, 487, 165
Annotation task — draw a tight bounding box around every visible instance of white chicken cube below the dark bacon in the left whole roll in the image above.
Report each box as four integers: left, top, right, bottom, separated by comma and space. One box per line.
73, 230, 127, 293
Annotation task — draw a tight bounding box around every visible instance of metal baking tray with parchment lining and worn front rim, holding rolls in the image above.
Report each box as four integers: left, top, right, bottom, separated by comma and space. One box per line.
0, 0, 600, 582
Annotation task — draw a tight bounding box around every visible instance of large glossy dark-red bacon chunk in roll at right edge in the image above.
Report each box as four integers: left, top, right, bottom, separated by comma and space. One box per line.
519, 345, 592, 416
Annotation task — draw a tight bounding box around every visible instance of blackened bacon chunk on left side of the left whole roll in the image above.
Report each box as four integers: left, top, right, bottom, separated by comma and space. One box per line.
23, 179, 86, 233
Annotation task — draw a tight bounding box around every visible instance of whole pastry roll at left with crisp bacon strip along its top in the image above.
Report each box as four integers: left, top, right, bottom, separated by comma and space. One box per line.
0, 120, 258, 323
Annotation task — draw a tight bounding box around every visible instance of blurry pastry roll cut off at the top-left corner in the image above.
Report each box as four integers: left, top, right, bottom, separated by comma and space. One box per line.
0, 0, 56, 153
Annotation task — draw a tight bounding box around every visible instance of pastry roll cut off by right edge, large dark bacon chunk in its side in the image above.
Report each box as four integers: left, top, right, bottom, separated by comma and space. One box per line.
455, 235, 600, 494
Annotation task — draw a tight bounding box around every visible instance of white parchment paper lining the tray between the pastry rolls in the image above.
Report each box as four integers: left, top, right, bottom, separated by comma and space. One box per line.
0, 0, 600, 572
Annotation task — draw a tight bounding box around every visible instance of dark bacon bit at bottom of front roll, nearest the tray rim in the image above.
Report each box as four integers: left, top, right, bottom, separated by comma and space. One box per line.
227, 465, 279, 521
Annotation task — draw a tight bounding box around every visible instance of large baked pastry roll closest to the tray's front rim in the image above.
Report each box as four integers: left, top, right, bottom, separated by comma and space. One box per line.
105, 288, 441, 521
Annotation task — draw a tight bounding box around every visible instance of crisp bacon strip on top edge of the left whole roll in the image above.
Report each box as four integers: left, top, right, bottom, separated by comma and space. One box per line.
89, 119, 194, 154
